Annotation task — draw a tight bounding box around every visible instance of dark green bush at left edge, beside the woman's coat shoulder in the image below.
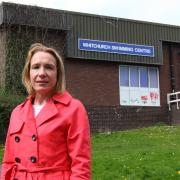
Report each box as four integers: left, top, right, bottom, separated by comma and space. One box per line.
0, 92, 25, 144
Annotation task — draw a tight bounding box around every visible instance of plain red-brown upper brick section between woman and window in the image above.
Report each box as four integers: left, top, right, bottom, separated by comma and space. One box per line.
65, 59, 119, 106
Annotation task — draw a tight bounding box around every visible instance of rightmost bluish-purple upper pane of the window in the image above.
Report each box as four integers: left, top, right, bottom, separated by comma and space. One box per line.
149, 68, 158, 88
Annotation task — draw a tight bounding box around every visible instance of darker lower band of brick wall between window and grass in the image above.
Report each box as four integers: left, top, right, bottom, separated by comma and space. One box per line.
86, 106, 169, 132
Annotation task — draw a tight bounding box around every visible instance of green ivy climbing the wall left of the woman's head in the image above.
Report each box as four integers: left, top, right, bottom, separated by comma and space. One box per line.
5, 26, 33, 95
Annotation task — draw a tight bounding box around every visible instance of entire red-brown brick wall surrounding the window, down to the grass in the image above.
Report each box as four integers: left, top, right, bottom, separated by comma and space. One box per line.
65, 54, 171, 131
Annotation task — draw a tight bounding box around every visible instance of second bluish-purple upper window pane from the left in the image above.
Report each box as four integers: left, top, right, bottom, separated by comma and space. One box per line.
130, 66, 139, 87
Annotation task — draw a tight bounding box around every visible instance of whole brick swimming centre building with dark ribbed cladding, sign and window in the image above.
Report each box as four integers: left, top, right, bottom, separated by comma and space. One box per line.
0, 3, 180, 131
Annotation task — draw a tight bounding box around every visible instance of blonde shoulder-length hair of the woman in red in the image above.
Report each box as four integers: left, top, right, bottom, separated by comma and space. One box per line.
22, 43, 65, 95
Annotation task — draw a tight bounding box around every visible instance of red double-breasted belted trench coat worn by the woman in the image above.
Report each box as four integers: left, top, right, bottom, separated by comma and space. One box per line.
1, 92, 90, 180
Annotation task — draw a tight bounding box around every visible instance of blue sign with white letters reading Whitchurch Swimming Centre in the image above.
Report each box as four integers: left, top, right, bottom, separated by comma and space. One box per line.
78, 39, 154, 57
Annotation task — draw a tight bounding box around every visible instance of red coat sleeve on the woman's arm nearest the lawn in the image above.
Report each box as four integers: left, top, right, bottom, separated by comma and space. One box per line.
67, 100, 91, 180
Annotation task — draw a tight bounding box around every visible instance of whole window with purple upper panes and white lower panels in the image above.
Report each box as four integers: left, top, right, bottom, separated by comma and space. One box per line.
119, 65, 160, 106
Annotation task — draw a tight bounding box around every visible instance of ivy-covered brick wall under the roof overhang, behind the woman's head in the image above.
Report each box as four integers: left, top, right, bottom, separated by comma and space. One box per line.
1, 25, 66, 95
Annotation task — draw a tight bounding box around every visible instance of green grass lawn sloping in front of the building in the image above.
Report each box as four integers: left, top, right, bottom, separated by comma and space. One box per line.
92, 126, 180, 180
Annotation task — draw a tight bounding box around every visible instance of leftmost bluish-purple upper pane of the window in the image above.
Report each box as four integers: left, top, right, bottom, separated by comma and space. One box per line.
120, 66, 129, 86
